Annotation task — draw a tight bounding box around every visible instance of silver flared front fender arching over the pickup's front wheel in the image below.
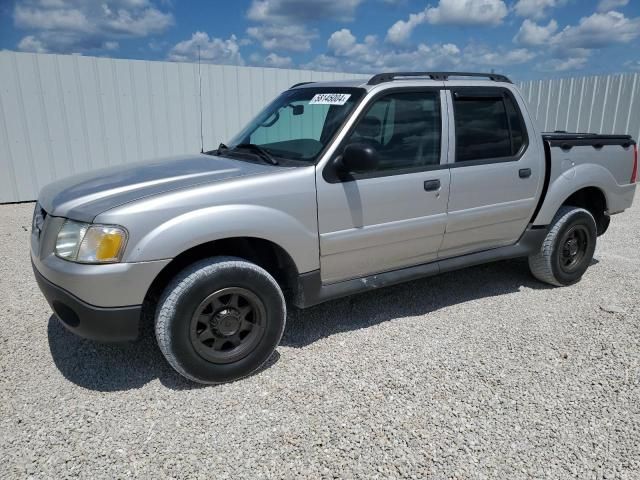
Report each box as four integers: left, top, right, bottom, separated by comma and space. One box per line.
126, 204, 319, 273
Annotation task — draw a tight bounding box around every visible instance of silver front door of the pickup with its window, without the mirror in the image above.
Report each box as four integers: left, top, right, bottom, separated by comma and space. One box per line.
317, 88, 450, 284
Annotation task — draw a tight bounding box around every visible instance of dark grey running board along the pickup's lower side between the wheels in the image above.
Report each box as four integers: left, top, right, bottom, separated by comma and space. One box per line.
293, 228, 547, 308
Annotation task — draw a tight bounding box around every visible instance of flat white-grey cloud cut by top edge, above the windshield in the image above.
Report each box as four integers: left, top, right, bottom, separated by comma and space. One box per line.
247, 0, 363, 24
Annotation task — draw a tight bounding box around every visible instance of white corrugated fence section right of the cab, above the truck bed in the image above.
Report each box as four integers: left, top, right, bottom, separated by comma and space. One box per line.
519, 73, 640, 139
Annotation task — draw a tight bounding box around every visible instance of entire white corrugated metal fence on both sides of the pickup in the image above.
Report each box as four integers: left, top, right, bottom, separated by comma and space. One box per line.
0, 51, 640, 203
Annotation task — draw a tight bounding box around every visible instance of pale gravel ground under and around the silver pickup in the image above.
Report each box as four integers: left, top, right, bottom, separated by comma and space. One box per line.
0, 201, 640, 479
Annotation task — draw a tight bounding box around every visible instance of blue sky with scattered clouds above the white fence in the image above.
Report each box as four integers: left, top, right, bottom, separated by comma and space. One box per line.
0, 0, 640, 79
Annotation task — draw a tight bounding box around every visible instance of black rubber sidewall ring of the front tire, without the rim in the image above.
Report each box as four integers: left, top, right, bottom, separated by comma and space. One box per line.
162, 261, 286, 383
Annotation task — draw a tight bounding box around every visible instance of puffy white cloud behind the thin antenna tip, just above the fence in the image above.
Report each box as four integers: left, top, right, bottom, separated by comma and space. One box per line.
167, 32, 244, 65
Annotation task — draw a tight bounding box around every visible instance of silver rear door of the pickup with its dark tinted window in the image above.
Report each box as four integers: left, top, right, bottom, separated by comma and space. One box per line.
439, 87, 544, 258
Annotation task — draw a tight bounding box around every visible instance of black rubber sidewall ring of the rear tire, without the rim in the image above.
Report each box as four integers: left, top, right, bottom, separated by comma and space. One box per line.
551, 209, 598, 285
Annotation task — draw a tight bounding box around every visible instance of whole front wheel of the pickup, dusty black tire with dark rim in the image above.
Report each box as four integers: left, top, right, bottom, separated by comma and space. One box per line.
155, 257, 286, 384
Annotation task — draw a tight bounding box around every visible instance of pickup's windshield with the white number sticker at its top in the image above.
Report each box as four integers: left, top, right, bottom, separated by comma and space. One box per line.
227, 87, 365, 163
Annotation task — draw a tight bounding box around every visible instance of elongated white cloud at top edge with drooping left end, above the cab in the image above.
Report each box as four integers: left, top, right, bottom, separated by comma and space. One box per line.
386, 0, 508, 45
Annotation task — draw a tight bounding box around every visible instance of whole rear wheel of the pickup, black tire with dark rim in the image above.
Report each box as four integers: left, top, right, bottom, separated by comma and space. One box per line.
529, 206, 597, 287
